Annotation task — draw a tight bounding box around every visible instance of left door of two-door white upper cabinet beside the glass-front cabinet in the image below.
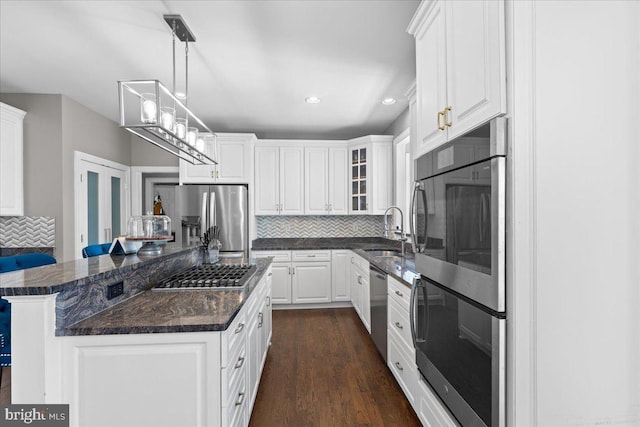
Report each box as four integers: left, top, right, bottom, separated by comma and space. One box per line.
304, 148, 328, 215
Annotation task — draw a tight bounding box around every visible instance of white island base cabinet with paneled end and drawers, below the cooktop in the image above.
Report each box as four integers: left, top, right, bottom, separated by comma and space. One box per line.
58, 270, 272, 427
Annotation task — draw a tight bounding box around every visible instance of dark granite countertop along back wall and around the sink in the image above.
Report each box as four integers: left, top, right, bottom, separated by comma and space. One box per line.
251, 237, 416, 286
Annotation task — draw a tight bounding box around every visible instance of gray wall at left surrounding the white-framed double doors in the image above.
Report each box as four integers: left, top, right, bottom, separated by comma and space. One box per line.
0, 94, 131, 261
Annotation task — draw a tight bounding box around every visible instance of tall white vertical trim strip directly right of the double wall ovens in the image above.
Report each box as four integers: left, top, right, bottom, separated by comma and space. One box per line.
506, 0, 538, 427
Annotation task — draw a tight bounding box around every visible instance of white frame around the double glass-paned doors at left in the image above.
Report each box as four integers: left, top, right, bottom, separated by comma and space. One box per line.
73, 150, 131, 259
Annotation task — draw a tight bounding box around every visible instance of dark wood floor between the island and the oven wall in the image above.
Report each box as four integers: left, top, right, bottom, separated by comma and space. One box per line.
250, 308, 421, 427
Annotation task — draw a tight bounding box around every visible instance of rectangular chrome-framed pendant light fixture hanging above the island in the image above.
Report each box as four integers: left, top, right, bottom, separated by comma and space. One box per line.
118, 15, 218, 165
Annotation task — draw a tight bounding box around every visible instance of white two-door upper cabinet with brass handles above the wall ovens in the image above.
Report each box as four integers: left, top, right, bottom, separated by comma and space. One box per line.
408, 0, 506, 156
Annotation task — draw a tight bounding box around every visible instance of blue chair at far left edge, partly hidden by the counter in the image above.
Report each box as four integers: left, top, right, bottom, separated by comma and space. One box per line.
0, 253, 56, 383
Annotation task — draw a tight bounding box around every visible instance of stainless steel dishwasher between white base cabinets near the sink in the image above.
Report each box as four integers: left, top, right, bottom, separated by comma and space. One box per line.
369, 263, 387, 362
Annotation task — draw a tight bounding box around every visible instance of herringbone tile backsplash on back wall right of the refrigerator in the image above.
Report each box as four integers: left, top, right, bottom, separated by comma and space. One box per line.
256, 215, 384, 238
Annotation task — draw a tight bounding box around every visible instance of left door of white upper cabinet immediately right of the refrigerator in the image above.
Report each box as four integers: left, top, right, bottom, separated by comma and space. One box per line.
254, 147, 280, 215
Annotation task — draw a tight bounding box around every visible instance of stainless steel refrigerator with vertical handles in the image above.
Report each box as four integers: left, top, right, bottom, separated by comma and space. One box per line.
171, 184, 249, 258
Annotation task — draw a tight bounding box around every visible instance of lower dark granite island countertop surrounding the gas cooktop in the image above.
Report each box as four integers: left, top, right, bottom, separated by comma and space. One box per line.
64, 259, 271, 335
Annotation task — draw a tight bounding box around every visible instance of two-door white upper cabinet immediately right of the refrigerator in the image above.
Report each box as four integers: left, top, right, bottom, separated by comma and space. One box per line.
255, 146, 304, 215
